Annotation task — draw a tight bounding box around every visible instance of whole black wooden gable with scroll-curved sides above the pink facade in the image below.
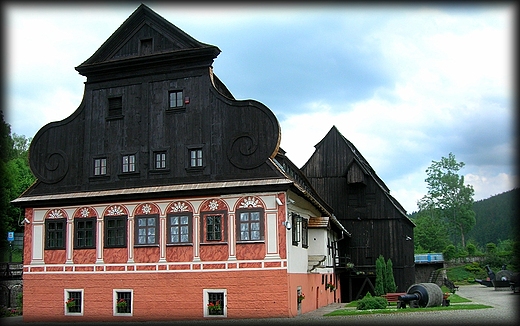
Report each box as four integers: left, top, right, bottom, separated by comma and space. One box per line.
22, 5, 284, 201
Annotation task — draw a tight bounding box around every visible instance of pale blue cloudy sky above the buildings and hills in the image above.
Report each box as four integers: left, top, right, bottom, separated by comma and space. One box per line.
2, 2, 518, 213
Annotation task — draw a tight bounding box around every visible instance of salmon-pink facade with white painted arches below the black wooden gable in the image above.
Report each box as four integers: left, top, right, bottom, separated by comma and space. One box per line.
24, 193, 340, 321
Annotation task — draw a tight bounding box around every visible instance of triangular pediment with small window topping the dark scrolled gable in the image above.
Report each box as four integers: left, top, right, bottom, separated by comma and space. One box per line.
76, 4, 220, 82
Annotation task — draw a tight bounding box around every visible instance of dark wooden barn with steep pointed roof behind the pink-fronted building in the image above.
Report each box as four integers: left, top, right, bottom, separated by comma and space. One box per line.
301, 126, 415, 301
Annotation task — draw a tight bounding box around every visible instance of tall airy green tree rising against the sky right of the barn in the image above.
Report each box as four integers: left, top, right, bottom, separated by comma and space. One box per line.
417, 153, 475, 247
